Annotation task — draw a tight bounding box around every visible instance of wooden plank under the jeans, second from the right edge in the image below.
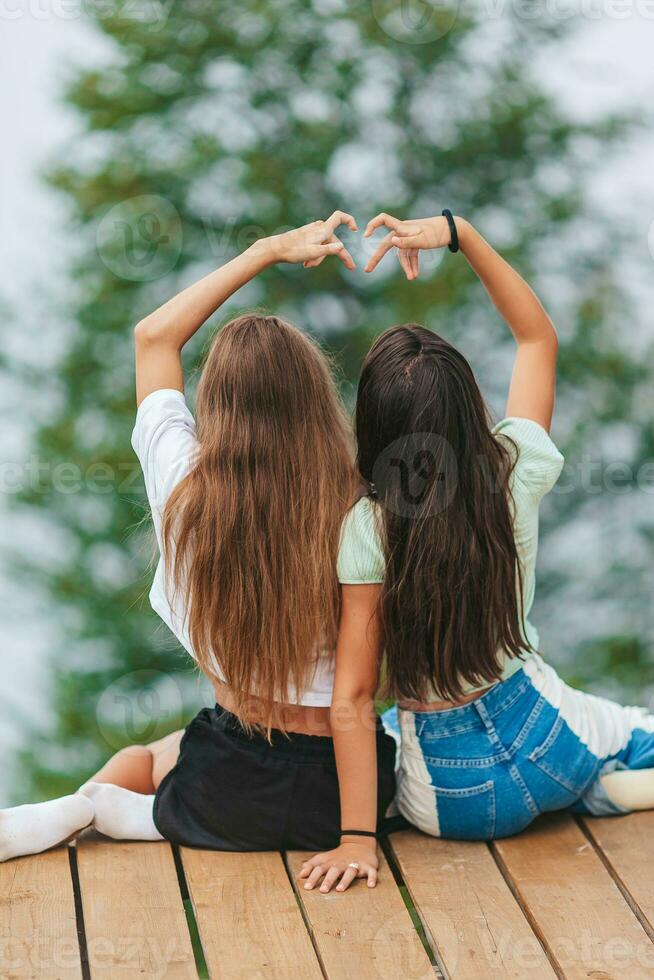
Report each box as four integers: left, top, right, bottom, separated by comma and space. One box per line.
492, 813, 654, 980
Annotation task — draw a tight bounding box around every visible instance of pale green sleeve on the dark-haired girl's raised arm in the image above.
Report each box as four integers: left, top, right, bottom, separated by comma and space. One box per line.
493, 418, 564, 498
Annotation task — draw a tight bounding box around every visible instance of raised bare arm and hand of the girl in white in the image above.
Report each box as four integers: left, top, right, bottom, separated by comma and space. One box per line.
134, 211, 356, 405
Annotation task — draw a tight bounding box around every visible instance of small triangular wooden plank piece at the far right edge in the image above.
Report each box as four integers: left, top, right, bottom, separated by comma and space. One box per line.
581, 810, 654, 937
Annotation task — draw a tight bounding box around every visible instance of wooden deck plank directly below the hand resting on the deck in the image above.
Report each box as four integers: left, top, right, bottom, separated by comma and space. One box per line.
287, 851, 435, 980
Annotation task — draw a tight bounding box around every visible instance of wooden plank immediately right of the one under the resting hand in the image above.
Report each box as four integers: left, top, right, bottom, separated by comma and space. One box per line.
390, 831, 556, 980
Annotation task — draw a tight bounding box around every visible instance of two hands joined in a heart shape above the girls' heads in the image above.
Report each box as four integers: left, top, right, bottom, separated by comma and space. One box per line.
268, 211, 461, 280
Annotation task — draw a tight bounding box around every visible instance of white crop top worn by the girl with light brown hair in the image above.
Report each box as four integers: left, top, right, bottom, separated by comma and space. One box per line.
132, 388, 356, 708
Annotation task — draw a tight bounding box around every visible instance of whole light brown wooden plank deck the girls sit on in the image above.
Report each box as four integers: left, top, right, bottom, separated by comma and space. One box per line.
0, 813, 654, 980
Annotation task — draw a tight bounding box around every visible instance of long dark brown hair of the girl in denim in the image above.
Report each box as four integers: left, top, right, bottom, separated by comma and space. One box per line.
356, 323, 529, 700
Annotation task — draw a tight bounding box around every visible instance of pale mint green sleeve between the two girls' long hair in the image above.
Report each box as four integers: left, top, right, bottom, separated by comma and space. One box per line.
337, 497, 386, 585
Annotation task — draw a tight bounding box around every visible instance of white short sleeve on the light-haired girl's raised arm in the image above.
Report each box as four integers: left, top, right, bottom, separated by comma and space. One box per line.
132, 388, 198, 516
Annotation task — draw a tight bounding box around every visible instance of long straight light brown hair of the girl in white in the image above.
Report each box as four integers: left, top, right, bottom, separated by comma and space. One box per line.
163, 314, 355, 728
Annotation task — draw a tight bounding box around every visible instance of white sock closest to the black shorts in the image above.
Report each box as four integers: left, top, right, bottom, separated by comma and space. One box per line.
78, 782, 164, 840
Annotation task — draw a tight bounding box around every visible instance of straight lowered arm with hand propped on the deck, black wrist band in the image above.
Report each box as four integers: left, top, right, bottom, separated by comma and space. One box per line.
300, 585, 381, 892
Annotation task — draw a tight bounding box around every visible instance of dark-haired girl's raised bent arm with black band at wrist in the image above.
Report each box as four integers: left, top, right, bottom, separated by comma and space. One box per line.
365, 214, 558, 430
